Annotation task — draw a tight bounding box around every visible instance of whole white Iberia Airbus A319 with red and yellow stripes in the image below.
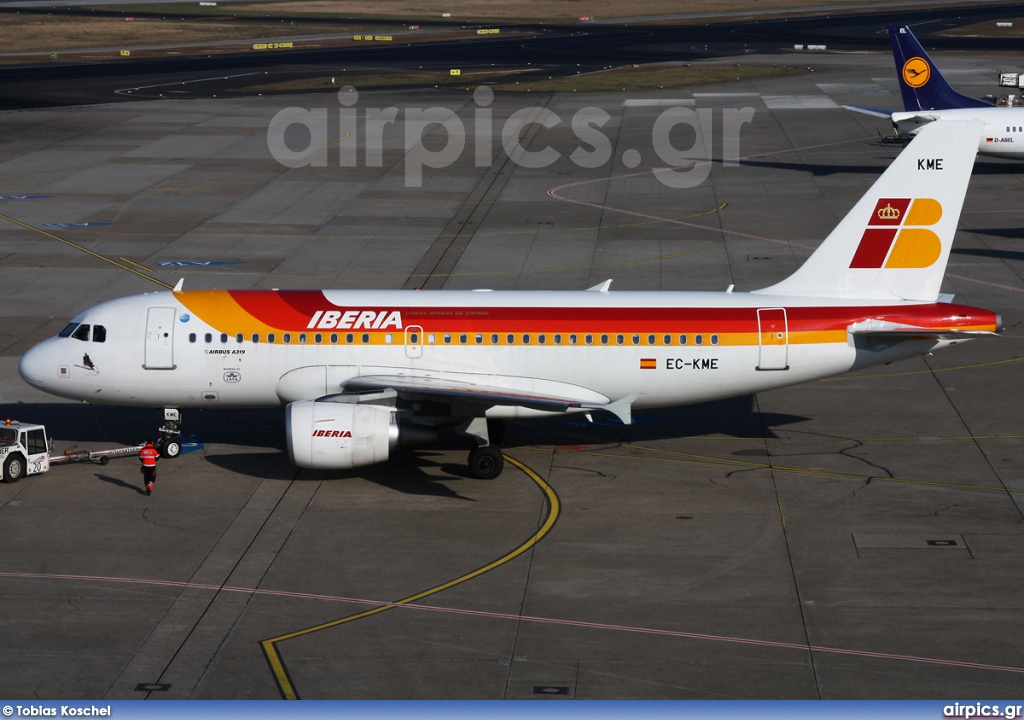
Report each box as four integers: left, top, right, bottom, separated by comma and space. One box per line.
19, 121, 1001, 478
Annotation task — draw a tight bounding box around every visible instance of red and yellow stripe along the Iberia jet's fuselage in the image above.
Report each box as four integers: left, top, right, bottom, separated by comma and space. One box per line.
175, 290, 996, 347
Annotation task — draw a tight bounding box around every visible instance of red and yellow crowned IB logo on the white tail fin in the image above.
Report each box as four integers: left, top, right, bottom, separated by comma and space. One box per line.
850, 198, 942, 268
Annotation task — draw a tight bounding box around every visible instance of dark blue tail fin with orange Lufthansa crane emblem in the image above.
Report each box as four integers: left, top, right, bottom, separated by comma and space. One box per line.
889, 26, 991, 113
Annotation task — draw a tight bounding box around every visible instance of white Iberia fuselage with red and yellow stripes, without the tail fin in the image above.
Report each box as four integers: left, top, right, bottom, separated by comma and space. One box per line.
20, 291, 991, 417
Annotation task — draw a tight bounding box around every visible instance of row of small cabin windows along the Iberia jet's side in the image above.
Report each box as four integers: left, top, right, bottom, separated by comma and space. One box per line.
188, 333, 719, 345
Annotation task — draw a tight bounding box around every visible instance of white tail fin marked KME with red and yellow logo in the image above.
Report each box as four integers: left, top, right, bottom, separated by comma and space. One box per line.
755, 120, 984, 302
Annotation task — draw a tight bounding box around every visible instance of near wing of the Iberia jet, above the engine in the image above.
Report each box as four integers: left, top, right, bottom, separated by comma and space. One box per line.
343, 375, 638, 425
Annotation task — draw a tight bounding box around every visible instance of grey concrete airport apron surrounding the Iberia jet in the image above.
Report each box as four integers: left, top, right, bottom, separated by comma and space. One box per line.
0, 49, 1024, 700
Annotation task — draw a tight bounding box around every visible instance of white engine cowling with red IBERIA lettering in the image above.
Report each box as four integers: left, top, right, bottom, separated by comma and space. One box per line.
285, 400, 398, 470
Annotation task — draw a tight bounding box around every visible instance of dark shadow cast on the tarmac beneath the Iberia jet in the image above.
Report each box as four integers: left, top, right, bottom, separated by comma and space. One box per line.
0, 395, 807, 493
